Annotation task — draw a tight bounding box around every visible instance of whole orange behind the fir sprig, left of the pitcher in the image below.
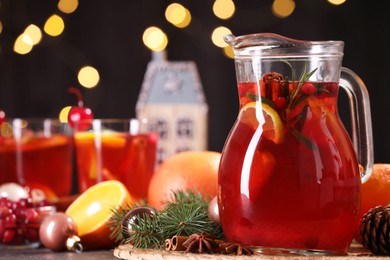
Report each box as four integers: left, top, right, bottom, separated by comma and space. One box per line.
148, 151, 221, 210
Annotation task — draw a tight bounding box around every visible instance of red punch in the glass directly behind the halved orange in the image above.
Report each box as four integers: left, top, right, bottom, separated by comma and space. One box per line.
75, 120, 158, 200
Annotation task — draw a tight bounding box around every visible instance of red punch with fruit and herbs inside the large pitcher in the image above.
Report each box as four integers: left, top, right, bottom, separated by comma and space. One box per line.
219, 74, 360, 252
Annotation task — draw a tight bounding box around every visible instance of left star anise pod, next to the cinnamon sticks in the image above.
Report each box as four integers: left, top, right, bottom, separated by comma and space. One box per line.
183, 232, 219, 254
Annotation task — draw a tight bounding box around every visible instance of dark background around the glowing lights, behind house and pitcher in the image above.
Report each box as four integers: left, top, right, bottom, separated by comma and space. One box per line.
0, 0, 390, 162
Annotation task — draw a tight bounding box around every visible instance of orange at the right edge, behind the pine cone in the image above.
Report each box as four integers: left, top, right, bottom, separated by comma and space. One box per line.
359, 163, 390, 219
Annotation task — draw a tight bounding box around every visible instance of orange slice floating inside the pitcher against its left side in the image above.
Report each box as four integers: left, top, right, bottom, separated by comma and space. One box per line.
238, 102, 284, 144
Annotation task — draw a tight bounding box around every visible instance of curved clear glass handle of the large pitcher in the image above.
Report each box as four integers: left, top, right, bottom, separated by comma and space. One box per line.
339, 67, 374, 183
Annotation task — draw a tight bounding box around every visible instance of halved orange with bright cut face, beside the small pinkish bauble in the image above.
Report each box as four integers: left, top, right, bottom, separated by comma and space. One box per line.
65, 180, 132, 250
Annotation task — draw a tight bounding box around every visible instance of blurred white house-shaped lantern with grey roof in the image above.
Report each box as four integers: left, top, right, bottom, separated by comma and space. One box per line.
136, 55, 208, 163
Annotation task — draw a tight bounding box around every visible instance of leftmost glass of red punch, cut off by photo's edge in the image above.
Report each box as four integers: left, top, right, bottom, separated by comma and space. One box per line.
0, 119, 73, 199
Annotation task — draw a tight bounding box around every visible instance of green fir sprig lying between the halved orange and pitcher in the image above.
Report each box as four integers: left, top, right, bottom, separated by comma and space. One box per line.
110, 191, 223, 248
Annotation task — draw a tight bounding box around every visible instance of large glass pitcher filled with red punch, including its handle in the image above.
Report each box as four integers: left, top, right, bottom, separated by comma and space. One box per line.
218, 33, 373, 254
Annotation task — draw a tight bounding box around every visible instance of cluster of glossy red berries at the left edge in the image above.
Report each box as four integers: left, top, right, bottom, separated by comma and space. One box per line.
0, 197, 52, 245
